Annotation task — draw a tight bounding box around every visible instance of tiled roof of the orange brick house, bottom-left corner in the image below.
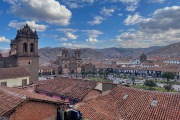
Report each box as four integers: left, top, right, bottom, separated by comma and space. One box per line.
0, 86, 64, 116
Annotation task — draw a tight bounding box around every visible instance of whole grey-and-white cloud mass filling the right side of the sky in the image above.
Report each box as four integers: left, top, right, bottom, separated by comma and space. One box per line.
114, 6, 180, 48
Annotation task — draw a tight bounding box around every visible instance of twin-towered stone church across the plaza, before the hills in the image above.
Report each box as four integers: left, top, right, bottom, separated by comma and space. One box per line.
58, 49, 82, 75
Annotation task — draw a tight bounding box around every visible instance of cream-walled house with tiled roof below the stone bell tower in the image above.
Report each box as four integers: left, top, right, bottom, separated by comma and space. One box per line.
0, 67, 30, 87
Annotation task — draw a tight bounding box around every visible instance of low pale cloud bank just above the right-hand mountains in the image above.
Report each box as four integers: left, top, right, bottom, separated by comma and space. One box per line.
114, 30, 180, 48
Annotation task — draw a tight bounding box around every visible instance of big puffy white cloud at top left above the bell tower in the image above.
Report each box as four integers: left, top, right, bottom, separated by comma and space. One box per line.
4, 0, 72, 25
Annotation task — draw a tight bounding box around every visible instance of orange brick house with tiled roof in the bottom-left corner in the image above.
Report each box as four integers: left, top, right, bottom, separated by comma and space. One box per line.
0, 86, 65, 120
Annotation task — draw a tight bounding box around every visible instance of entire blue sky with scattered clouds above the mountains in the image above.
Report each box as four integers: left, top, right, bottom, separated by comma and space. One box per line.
0, 0, 180, 49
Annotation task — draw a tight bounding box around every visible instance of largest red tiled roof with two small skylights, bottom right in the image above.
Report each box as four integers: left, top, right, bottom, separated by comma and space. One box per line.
77, 86, 180, 120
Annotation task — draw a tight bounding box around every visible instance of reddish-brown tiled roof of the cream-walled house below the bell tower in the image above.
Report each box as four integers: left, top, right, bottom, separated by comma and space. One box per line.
0, 67, 30, 79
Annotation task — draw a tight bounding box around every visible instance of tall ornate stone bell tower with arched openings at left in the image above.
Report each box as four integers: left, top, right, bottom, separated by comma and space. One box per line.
11, 24, 39, 83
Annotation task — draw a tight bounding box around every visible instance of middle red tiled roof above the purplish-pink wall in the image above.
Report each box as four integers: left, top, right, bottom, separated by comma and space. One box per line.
36, 77, 97, 99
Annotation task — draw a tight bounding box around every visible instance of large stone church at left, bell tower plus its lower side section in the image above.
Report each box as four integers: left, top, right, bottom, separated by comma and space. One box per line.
0, 24, 39, 83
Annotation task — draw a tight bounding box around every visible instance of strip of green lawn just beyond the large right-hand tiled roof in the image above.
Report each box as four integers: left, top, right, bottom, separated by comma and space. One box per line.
131, 85, 177, 92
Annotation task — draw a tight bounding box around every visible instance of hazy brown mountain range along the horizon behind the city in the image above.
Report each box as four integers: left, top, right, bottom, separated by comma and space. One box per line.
39, 42, 180, 64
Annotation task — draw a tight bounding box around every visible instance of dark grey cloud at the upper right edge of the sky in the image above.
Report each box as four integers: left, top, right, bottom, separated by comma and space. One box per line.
140, 6, 180, 30
